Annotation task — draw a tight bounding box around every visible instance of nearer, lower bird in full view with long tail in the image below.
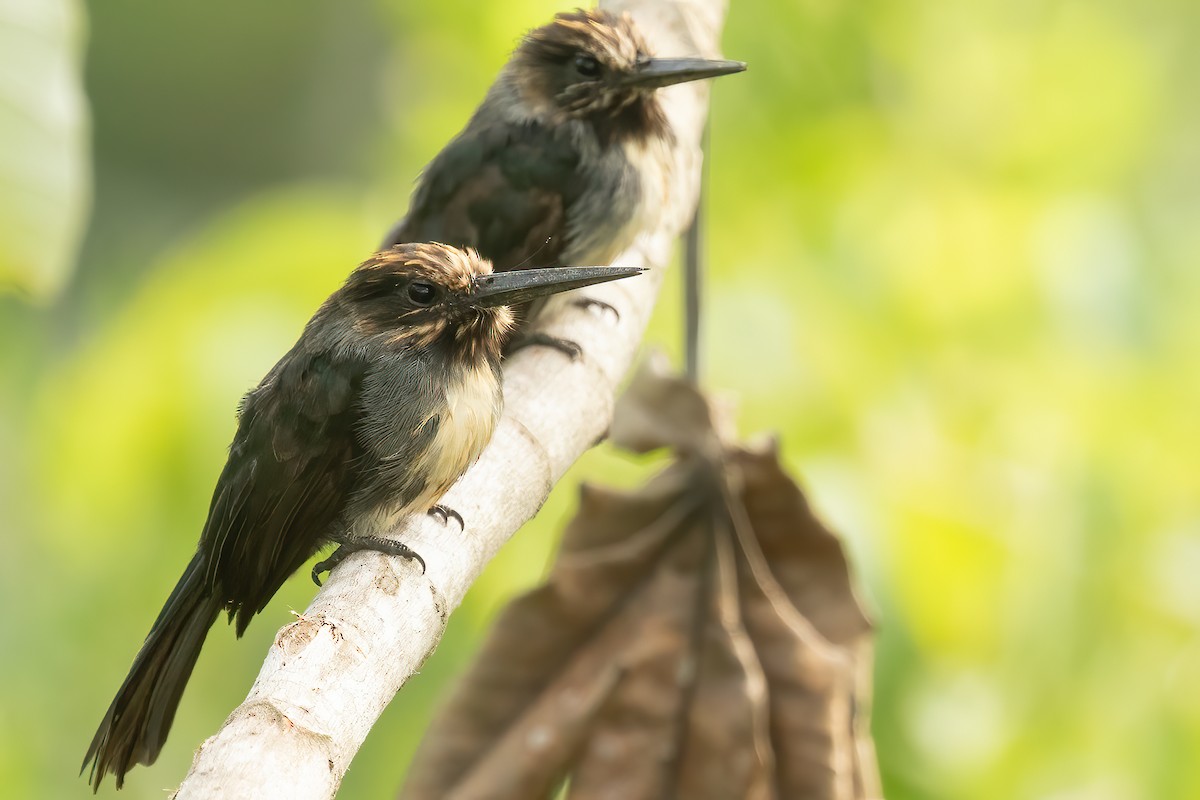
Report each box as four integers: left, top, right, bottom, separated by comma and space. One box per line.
80, 243, 642, 790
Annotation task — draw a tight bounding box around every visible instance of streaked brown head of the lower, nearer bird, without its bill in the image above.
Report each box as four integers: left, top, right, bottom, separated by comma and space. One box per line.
334, 242, 515, 359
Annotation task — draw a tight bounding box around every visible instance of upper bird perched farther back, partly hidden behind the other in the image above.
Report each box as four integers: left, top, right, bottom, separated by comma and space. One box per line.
383, 10, 746, 347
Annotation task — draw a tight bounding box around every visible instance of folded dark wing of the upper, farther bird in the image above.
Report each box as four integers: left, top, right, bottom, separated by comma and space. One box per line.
384, 124, 582, 270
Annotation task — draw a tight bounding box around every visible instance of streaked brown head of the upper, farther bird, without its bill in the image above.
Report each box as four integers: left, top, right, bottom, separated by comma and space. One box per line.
512, 8, 667, 136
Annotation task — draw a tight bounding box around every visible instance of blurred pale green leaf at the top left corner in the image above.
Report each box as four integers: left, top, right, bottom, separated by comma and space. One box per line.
0, 0, 90, 300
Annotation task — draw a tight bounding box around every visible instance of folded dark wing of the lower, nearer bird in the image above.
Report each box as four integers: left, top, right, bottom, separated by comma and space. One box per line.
200, 342, 367, 636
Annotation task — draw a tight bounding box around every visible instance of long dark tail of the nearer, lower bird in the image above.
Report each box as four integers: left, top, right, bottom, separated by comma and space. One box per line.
79, 553, 221, 789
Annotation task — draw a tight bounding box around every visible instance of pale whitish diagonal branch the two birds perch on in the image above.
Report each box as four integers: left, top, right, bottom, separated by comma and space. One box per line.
175, 0, 726, 800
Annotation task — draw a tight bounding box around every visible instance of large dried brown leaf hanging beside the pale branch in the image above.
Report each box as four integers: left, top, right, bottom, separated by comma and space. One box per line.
402, 373, 880, 800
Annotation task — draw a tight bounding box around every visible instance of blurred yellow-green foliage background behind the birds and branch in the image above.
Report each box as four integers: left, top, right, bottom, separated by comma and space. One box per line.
0, 0, 1200, 800
